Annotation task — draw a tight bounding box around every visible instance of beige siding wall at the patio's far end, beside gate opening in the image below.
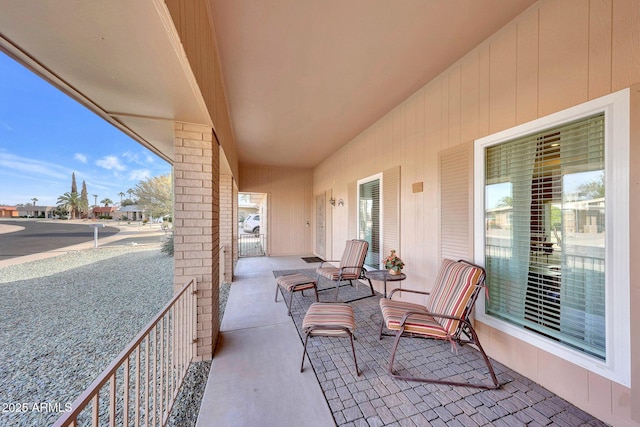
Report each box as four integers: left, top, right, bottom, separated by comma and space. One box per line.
238, 164, 315, 256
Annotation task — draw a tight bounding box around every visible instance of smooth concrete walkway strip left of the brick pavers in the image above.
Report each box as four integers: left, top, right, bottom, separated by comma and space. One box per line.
197, 257, 335, 427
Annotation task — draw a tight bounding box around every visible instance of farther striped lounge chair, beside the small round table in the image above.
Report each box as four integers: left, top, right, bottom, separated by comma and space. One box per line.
316, 240, 375, 301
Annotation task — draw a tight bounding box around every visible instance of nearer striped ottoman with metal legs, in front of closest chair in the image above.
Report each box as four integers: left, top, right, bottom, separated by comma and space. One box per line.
300, 302, 360, 376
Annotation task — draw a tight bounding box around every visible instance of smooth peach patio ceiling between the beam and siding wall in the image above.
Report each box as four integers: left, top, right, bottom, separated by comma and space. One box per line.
209, 0, 534, 167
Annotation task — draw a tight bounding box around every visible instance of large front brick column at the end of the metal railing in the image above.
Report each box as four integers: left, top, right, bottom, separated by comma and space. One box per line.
173, 122, 220, 361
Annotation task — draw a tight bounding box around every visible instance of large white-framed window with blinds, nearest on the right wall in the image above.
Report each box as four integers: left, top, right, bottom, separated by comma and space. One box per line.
474, 91, 630, 384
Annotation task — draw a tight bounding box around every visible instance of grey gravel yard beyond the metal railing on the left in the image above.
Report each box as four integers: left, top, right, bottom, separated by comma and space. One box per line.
0, 245, 175, 426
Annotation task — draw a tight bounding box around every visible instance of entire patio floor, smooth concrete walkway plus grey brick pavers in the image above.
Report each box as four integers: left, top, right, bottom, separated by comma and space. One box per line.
197, 257, 606, 427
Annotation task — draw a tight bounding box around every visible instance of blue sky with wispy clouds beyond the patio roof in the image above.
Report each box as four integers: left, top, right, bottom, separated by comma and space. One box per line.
0, 52, 171, 206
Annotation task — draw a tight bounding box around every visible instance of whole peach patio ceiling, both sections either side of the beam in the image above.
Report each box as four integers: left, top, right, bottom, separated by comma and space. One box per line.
0, 0, 535, 171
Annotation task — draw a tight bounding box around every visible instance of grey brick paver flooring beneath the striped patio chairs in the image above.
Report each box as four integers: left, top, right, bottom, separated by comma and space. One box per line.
274, 270, 606, 427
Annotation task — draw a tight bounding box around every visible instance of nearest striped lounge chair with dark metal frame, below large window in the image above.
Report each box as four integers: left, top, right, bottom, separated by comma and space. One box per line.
380, 259, 500, 389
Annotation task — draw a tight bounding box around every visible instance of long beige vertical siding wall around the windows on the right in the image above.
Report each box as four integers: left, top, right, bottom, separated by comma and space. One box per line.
313, 0, 640, 425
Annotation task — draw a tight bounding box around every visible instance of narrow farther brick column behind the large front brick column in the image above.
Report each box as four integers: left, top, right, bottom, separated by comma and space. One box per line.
220, 174, 238, 283
